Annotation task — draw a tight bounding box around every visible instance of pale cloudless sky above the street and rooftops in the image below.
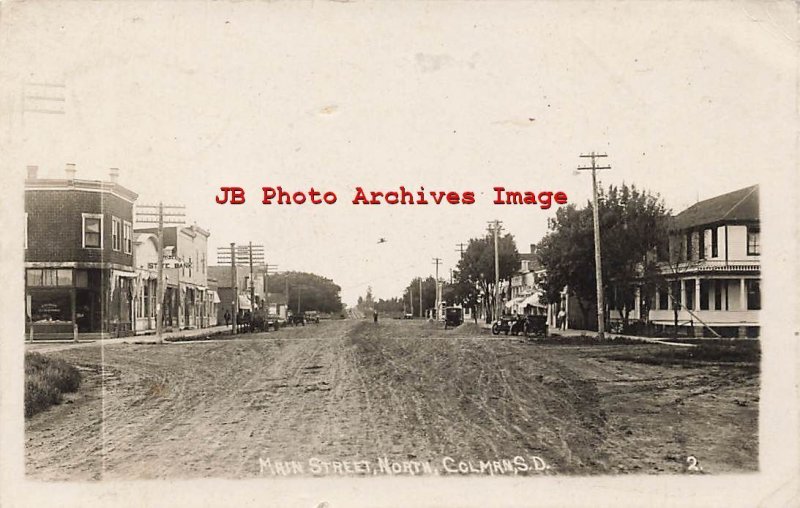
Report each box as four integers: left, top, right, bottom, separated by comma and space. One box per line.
0, 1, 796, 304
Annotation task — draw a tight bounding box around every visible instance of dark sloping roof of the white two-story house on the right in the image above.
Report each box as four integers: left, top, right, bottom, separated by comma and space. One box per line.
672, 185, 759, 230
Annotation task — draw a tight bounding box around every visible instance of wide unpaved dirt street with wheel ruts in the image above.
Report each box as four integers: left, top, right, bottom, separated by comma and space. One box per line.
26, 320, 758, 480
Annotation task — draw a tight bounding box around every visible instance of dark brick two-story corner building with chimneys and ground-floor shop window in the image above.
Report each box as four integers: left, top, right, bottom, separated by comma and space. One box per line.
25, 164, 137, 337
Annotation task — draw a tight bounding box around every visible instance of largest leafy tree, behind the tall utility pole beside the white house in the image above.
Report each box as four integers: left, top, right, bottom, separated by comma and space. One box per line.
536, 184, 670, 325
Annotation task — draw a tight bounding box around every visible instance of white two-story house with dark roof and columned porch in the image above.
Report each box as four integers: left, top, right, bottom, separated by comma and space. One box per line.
649, 185, 761, 337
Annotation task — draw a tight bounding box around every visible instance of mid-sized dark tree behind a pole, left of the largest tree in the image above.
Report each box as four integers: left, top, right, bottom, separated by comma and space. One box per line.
456, 234, 519, 318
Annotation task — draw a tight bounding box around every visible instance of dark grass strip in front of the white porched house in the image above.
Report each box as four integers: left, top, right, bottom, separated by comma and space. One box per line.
609, 339, 761, 366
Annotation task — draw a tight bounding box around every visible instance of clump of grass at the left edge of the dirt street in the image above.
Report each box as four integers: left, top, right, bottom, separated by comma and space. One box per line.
25, 353, 81, 418
